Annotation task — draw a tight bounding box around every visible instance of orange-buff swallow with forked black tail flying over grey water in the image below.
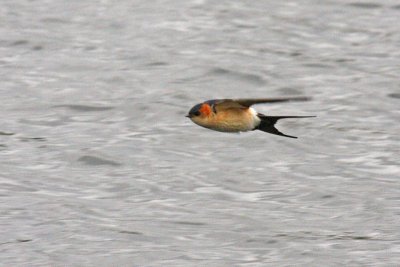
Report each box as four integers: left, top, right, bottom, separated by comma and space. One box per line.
186, 96, 315, 138
